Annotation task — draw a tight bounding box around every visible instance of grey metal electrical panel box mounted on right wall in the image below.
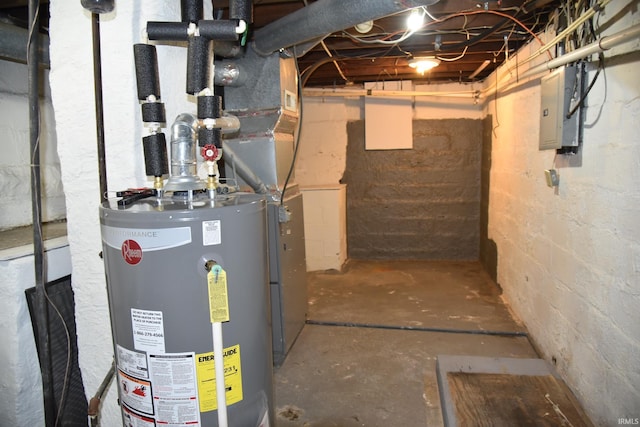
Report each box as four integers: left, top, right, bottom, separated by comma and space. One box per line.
539, 66, 579, 150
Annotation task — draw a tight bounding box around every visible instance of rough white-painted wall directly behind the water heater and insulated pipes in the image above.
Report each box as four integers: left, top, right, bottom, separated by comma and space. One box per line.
49, 0, 210, 426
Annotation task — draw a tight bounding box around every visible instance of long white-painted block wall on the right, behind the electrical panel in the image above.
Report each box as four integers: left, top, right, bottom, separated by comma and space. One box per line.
485, 2, 640, 425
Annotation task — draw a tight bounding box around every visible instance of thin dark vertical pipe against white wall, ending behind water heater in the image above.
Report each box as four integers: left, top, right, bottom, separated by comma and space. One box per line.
91, 13, 108, 202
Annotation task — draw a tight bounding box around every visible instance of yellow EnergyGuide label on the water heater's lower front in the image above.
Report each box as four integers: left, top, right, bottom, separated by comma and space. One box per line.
196, 345, 243, 412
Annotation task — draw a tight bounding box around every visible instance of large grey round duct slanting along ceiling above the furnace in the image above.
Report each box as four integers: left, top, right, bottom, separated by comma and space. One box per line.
253, 0, 438, 56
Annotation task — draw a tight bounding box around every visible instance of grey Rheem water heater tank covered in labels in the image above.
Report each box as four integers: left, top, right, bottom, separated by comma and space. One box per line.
100, 194, 274, 427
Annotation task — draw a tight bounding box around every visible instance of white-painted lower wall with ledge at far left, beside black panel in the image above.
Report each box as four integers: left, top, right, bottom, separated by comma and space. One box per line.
0, 237, 71, 426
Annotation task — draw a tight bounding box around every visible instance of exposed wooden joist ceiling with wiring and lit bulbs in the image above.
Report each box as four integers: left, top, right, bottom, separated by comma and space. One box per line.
0, 0, 562, 87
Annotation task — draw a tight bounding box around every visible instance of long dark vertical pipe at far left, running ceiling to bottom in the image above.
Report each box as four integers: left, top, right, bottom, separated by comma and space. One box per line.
27, 0, 56, 427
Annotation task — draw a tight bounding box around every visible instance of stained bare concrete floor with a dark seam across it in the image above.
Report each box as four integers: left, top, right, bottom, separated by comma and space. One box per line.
275, 261, 537, 427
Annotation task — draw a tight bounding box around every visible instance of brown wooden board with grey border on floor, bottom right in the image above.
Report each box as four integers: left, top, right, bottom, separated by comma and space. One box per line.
438, 356, 592, 427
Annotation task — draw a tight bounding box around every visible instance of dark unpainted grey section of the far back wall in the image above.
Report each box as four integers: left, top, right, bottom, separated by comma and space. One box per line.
343, 119, 482, 260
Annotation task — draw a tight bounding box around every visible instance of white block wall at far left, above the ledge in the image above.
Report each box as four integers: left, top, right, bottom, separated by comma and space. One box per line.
0, 60, 66, 230
